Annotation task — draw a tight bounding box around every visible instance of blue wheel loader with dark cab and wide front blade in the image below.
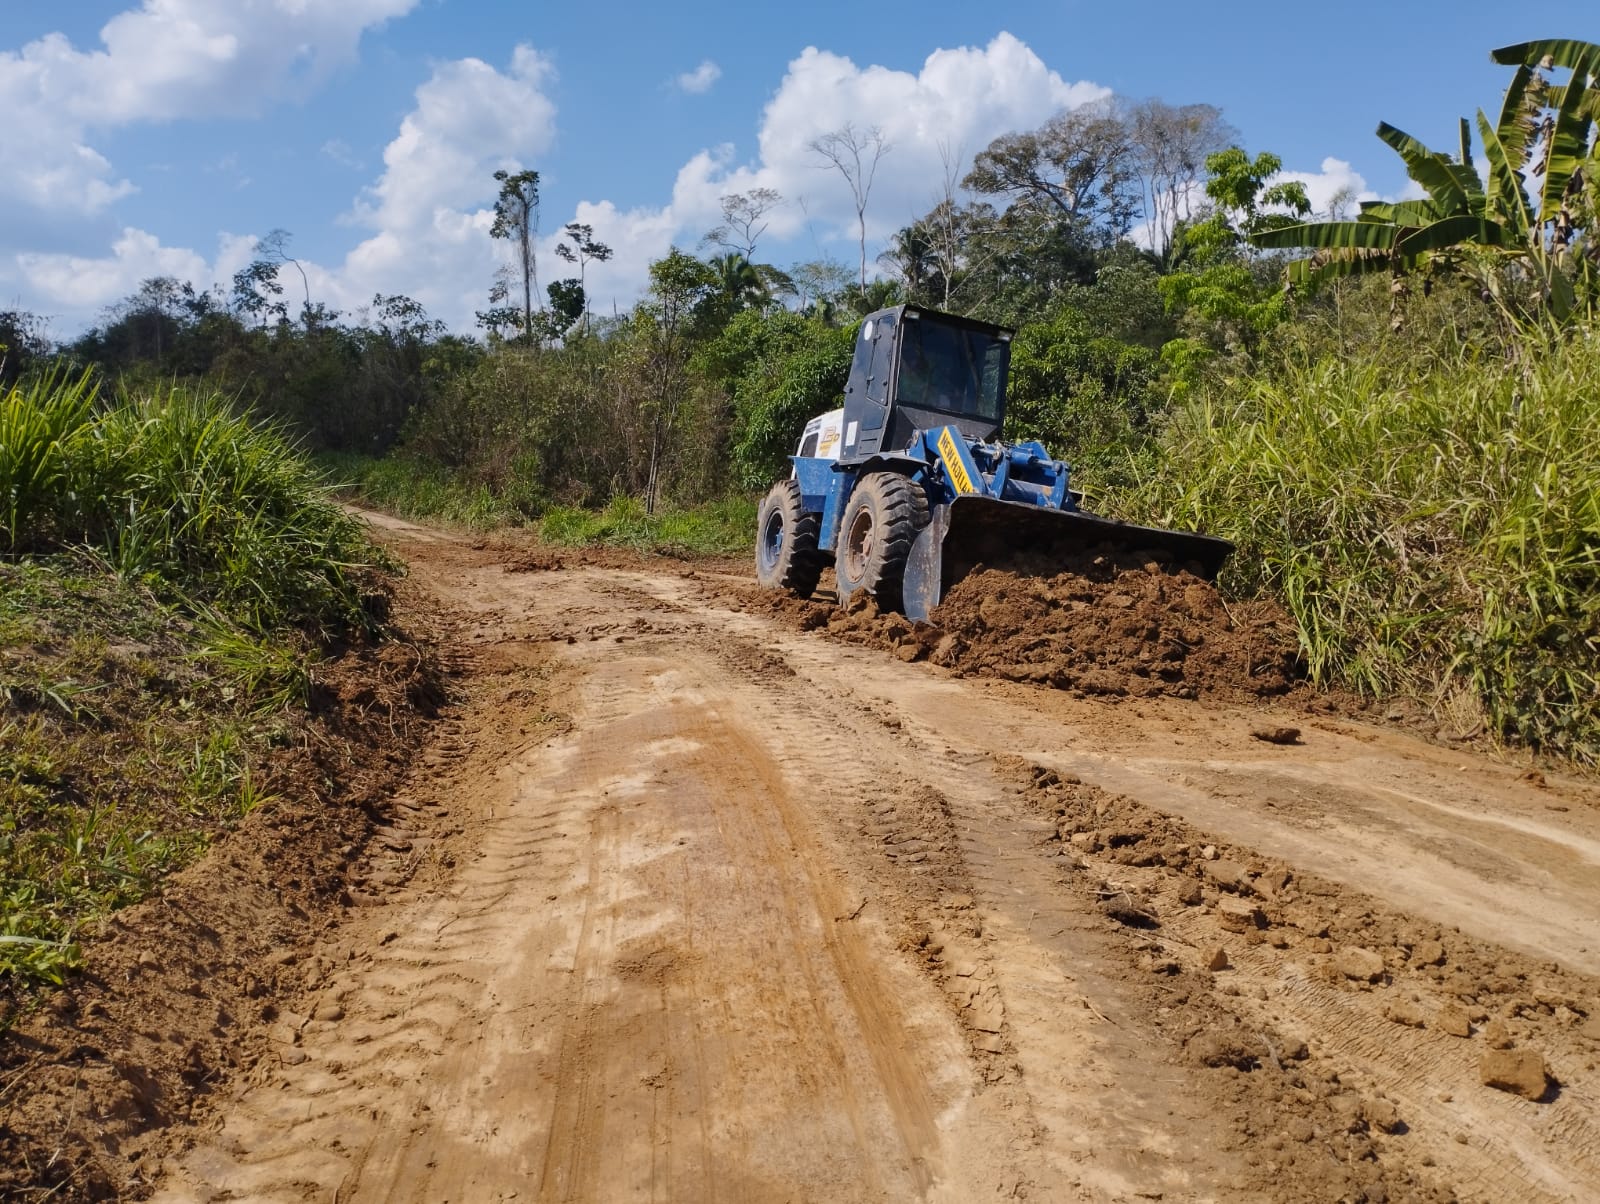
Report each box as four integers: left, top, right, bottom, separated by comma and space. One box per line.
755, 306, 1234, 620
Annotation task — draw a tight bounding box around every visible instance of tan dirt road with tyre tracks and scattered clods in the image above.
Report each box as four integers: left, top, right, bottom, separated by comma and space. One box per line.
157, 520, 1600, 1204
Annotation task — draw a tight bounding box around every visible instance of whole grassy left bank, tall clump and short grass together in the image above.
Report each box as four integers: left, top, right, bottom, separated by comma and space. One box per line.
0, 371, 387, 986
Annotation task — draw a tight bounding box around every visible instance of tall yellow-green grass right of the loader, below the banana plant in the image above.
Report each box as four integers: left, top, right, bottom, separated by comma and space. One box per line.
1130, 333, 1600, 764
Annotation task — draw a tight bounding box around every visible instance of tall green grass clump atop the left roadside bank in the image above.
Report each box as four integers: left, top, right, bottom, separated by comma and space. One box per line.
0, 375, 381, 637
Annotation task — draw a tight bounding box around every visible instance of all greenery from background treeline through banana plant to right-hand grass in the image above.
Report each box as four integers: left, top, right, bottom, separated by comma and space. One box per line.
0, 42, 1600, 762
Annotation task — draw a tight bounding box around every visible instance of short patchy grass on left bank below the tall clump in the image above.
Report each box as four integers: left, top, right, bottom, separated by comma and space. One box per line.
0, 557, 283, 985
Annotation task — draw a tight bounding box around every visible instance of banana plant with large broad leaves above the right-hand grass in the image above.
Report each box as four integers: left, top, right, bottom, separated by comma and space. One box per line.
1251, 38, 1600, 319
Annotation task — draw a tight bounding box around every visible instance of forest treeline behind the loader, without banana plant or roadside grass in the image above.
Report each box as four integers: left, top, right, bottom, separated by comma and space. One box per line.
0, 91, 1337, 517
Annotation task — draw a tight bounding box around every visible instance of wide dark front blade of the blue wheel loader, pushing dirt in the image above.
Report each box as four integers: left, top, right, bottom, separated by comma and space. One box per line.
902, 496, 1234, 621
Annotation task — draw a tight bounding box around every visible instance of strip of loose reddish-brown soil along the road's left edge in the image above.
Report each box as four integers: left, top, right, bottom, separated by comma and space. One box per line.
0, 604, 442, 1201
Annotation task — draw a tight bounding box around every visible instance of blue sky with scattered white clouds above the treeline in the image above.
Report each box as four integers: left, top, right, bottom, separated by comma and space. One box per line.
0, 0, 1600, 335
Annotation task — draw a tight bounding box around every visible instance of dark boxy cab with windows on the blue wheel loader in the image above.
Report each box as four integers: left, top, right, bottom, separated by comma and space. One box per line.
838, 306, 1013, 464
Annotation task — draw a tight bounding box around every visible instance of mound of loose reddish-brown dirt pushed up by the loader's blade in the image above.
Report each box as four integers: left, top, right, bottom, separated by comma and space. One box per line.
742, 548, 1304, 700
